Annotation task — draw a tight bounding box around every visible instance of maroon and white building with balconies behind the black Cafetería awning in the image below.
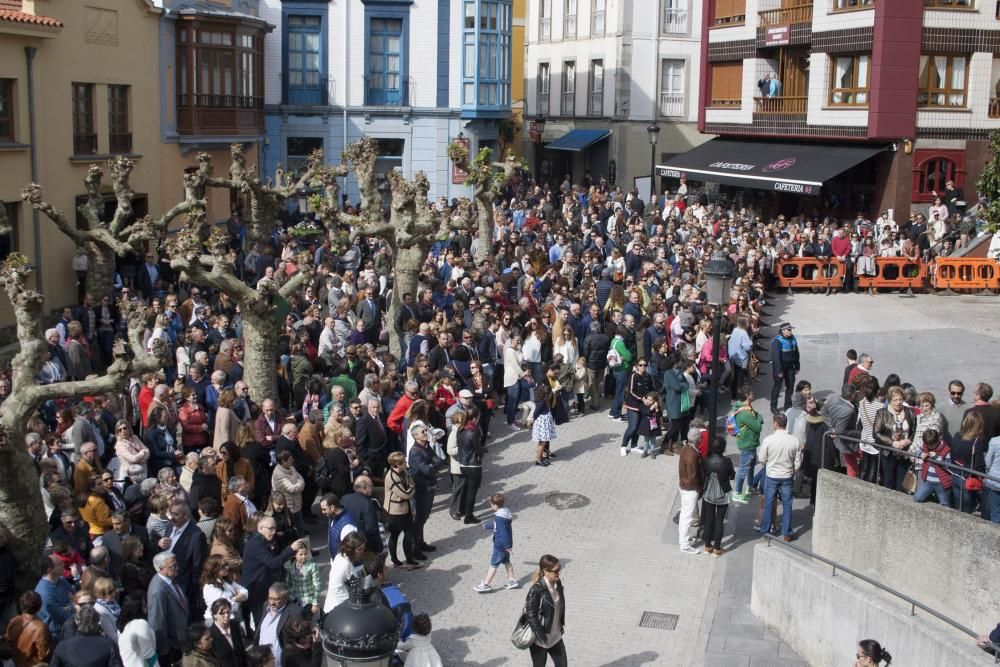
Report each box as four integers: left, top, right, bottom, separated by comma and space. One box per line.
684, 0, 1000, 220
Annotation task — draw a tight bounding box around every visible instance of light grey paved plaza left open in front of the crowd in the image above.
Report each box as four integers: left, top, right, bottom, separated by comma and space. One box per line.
306, 294, 1000, 667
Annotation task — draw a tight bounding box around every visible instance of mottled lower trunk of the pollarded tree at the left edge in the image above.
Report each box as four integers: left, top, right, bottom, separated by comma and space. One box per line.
0, 428, 48, 591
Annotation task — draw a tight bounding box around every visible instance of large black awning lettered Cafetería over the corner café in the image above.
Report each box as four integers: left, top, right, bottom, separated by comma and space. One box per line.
656, 139, 885, 195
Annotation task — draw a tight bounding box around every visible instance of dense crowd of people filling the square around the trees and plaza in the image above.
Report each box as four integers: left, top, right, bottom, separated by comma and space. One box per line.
0, 162, 1000, 667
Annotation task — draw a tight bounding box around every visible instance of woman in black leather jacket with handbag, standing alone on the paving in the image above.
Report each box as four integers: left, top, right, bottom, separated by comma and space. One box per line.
524, 554, 568, 667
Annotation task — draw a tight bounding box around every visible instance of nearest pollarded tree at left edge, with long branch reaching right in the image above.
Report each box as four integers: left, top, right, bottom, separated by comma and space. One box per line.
0, 214, 165, 590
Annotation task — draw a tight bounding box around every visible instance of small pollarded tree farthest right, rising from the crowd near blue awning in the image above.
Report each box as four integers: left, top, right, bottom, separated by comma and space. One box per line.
448, 144, 526, 264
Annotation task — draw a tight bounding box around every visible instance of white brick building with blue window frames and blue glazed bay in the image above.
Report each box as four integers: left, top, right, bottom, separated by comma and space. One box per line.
261, 0, 512, 201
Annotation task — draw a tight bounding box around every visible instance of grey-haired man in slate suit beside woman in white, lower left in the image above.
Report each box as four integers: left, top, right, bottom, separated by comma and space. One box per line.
146, 552, 188, 665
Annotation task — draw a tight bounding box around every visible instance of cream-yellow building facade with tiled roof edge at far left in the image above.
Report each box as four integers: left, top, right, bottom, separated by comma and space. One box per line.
0, 0, 162, 325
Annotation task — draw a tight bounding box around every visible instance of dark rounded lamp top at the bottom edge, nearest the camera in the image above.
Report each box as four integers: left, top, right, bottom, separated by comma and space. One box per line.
320, 574, 399, 667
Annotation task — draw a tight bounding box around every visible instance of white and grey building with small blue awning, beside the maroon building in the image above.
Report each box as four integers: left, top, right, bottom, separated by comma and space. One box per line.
525, 0, 708, 196
